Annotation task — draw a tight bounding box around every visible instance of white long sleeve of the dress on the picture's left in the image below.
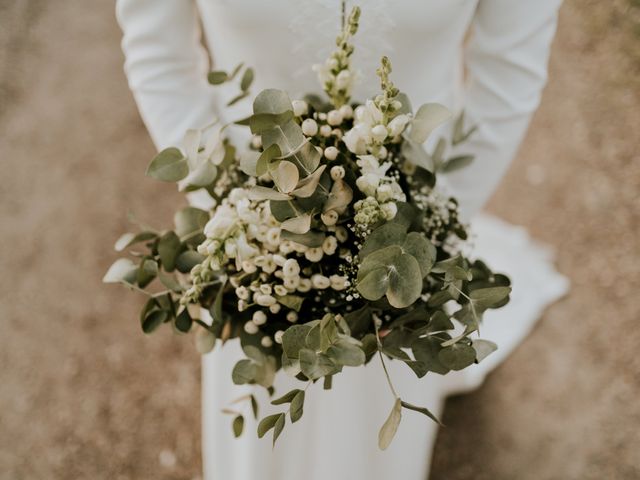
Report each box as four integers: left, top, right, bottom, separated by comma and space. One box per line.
116, 0, 214, 149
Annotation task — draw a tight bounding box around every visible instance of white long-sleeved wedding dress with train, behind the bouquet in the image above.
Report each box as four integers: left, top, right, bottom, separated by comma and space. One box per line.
117, 0, 568, 480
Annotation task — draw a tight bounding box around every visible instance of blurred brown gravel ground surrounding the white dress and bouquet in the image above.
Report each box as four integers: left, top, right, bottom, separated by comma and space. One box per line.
0, 0, 640, 480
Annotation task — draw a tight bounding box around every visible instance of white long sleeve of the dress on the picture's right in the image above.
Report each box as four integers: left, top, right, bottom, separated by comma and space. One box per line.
447, 0, 561, 218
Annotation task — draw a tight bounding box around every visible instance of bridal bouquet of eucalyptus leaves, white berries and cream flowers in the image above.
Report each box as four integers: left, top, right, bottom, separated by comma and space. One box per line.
104, 8, 510, 449
